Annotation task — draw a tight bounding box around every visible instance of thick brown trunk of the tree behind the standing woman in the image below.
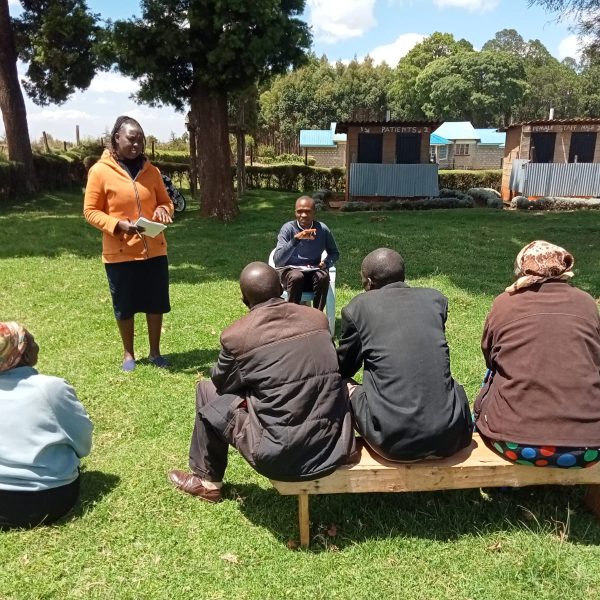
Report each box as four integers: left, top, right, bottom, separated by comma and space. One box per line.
191, 85, 239, 221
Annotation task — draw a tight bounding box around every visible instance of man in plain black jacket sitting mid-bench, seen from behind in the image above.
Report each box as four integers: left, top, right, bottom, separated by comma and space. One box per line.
338, 248, 472, 461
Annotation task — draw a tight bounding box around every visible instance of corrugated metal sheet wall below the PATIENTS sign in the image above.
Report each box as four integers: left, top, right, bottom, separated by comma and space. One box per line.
349, 163, 440, 198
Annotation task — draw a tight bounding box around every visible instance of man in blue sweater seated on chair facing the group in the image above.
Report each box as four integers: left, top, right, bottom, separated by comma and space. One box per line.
273, 196, 340, 310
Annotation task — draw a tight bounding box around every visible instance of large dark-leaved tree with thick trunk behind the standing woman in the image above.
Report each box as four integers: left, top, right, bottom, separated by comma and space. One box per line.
114, 0, 310, 220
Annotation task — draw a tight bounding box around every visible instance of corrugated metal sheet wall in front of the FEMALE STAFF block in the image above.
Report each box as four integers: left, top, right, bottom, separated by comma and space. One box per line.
510, 160, 600, 196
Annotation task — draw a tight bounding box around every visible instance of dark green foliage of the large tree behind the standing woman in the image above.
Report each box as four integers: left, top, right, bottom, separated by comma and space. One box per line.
113, 0, 310, 110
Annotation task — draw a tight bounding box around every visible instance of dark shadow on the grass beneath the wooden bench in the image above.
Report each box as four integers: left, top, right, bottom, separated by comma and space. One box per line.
231, 484, 600, 552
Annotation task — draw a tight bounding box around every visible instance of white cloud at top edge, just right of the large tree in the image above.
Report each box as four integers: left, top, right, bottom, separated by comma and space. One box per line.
308, 0, 376, 43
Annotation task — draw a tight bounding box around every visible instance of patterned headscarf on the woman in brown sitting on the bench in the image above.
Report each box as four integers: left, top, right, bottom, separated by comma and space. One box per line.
506, 240, 575, 294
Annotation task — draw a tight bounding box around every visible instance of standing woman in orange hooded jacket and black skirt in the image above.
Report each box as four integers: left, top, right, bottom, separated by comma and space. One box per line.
83, 116, 173, 371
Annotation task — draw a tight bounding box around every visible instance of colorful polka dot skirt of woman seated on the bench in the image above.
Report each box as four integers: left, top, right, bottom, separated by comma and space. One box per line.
489, 440, 600, 469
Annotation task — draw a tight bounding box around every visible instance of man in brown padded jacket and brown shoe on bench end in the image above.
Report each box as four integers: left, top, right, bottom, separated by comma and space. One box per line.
169, 262, 355, 502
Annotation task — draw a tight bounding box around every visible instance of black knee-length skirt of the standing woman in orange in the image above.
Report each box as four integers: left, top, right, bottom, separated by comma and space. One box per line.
104, 256, 171, 321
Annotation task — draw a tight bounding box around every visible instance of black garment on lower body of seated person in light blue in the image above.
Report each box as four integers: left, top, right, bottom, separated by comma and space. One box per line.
0, 477, 79, 529
